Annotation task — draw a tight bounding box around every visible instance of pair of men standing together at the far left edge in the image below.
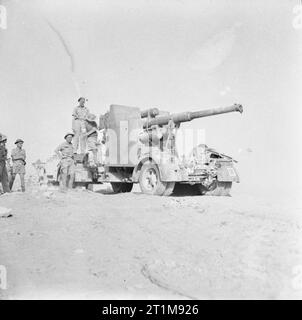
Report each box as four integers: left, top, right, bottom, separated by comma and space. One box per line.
0, 133, 26, 194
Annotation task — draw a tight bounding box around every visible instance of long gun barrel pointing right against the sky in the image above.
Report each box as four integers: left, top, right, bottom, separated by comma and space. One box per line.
143, 104, 243, 128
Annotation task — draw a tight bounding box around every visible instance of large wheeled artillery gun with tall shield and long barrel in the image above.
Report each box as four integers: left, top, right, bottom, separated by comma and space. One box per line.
49, 104, 243, 196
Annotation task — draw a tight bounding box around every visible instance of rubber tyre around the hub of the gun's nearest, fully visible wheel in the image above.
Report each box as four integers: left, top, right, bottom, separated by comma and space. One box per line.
138, 162, 170, 196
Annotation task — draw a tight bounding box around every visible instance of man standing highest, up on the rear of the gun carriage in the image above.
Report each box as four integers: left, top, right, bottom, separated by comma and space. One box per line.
72, 97, 89, 153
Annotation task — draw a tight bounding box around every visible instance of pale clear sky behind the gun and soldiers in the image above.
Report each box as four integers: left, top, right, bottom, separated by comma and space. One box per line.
0, 0, 302, 196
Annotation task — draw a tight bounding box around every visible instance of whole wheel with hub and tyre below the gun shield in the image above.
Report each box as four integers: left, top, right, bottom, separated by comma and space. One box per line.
138, 162, 174, 196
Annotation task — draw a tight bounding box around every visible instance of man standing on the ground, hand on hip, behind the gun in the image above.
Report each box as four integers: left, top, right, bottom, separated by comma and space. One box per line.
55, 133, 75, 191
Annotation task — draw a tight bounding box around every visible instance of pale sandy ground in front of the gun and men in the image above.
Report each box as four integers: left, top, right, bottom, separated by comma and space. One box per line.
0, 180, 302, 299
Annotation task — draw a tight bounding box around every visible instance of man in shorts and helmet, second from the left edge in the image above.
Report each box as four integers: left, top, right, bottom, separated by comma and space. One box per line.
9, 139, 26, 192
